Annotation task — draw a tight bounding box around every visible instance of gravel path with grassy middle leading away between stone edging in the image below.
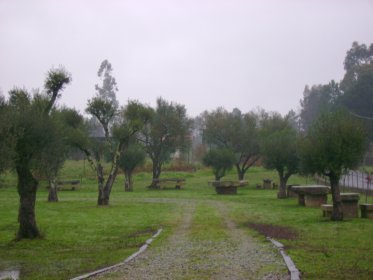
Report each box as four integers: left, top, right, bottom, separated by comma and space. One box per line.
95, 200, 290, 280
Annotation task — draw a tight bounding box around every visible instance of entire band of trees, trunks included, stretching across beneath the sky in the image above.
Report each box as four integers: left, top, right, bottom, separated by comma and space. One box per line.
0, 42, 373, 239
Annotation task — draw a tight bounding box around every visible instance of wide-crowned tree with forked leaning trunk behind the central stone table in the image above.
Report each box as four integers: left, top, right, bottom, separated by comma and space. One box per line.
203, 108, 260, 180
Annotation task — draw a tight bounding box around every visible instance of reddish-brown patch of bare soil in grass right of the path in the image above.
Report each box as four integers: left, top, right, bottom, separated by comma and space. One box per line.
248, 223, 298, 240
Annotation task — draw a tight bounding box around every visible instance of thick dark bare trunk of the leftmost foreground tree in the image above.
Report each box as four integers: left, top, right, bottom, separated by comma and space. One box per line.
16, 163, 41, 240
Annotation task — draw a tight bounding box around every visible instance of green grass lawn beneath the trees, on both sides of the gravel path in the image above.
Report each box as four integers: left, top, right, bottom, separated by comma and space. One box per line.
0, 162, 373, 279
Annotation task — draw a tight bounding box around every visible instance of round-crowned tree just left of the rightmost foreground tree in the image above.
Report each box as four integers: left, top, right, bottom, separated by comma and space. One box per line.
261, 114, 299, 198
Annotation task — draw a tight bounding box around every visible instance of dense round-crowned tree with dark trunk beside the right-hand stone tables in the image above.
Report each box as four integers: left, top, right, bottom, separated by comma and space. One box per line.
300, 110, 367, 221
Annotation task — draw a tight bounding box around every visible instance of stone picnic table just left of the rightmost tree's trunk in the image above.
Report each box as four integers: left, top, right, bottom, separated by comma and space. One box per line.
291, 185, 330, 207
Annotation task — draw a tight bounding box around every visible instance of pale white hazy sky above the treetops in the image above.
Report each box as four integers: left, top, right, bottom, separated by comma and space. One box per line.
0, 0, 373, 116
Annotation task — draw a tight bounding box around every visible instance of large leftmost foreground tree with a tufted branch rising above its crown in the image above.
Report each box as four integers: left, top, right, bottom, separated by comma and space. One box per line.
8, 68, 71, 239
